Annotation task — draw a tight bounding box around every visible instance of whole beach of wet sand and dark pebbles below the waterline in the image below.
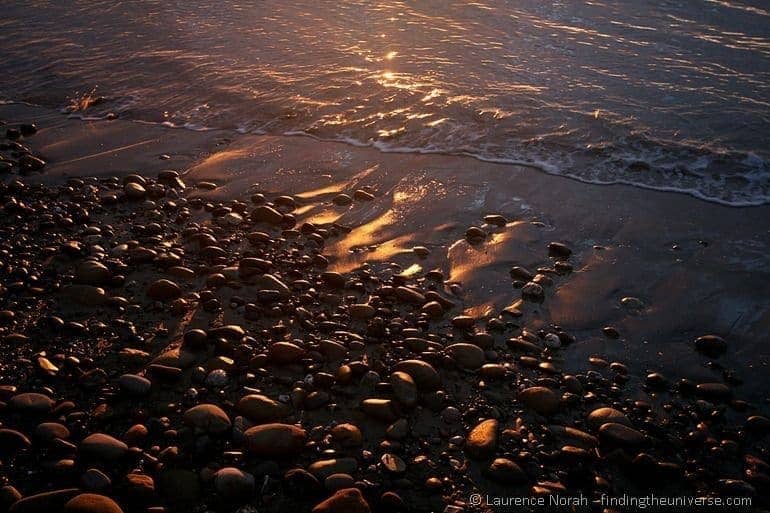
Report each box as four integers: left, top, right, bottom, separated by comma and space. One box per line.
0, 104, 770, 512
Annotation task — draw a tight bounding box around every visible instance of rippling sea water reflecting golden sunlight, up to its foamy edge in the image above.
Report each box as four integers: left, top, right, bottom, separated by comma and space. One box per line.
0, 0, 770, 205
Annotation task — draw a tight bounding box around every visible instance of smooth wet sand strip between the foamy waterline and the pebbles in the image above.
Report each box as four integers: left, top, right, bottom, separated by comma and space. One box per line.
0, 102, 770, 399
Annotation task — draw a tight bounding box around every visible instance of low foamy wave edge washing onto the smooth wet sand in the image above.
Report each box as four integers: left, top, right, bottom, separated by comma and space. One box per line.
0, 99, 770, 207
